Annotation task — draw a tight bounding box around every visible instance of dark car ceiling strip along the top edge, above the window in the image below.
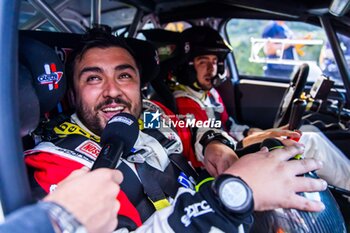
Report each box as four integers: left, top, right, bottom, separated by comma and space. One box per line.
116, 0, 350, 22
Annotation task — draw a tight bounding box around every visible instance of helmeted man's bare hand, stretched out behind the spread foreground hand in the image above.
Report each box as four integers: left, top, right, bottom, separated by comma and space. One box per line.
242, 126, 301, 147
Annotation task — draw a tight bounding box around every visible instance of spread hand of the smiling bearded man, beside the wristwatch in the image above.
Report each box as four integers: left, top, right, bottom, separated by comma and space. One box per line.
224, 143, 327, 211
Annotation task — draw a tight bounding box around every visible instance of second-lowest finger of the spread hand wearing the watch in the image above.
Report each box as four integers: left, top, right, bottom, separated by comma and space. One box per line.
293, 176, 327, 195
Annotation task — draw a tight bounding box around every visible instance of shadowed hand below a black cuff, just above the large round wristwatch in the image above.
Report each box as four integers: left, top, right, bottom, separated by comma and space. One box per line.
203, 141, 238, 177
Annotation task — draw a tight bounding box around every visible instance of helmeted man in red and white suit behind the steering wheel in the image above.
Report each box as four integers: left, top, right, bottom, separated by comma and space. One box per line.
174, 27, 350, 190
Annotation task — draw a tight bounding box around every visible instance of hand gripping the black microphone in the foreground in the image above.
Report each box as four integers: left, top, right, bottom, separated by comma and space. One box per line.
44, 167, 123, 233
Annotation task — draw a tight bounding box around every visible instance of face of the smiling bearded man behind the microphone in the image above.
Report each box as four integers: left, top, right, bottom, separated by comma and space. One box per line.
74, 47, 141, 135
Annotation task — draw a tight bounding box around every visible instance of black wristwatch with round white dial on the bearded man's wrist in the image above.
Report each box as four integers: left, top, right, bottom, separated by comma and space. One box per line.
212, 174, 254, 214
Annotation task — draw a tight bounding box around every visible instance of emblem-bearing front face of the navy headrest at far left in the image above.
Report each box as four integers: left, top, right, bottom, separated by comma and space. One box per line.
19, 36, 67, 115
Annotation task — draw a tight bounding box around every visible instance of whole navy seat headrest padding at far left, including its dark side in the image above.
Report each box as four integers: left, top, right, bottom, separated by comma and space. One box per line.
19, 36, 67, 137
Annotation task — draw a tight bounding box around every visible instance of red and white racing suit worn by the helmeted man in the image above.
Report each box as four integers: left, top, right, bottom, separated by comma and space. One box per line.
174, 86, 350, 190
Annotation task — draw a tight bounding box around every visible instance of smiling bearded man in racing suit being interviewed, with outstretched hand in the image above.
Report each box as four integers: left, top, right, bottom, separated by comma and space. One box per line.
25, 31, 326, 232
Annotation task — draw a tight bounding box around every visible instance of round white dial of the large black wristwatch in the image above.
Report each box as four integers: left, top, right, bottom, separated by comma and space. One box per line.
220, 179, 248, 209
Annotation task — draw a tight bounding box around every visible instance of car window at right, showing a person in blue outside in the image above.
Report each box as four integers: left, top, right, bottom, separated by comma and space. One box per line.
226, 19, 341, 82
